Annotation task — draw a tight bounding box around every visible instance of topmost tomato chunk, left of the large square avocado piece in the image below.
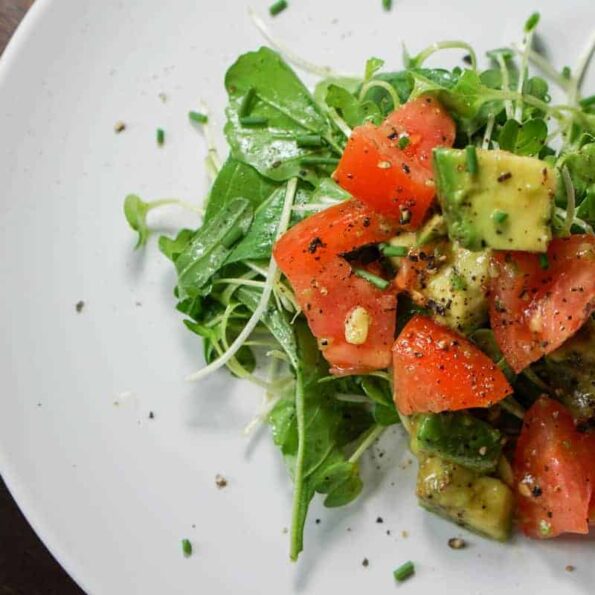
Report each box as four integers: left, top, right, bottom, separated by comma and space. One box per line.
334, 97, 455, 229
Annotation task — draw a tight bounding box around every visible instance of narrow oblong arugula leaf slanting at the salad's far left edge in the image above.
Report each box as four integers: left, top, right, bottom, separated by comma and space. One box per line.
175, 198, 252, 300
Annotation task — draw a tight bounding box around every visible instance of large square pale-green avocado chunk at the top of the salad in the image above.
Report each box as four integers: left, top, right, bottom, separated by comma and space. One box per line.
433, 149, 556, 252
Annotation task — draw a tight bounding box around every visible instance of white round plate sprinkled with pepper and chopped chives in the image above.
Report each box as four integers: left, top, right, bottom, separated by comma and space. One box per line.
0, 0, 595, 595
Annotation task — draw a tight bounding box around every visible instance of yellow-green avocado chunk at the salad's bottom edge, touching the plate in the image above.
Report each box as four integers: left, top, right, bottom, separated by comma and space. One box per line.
416, 456, 514, 541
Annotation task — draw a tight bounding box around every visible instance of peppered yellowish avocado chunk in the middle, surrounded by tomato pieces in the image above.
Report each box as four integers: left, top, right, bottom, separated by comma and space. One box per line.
420, 244, 490, 334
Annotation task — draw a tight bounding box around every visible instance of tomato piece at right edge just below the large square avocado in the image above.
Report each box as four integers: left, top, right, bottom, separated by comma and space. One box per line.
490, 235, 595, 372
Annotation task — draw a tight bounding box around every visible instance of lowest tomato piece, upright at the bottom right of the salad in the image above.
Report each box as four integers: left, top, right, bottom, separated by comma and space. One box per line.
513, 397, 593, 539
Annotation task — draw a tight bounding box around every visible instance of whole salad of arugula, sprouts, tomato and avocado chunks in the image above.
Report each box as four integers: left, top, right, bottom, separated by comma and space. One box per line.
124, 14, 595, 560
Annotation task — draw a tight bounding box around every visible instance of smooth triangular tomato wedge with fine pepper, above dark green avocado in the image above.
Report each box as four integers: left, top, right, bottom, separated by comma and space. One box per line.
393, 315, 512, 415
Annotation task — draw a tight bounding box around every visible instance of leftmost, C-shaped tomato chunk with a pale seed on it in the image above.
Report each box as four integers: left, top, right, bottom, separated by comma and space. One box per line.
273, 200, 397, 374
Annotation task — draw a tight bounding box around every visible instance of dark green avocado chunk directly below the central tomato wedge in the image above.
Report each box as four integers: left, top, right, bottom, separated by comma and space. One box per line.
412, 413, 502, 474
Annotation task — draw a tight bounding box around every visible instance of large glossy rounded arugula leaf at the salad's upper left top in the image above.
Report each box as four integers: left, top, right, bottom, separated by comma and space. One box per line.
225, 47, 341, 182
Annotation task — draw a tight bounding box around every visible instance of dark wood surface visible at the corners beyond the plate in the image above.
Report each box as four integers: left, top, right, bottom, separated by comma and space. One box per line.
0, 0, 82, 595
